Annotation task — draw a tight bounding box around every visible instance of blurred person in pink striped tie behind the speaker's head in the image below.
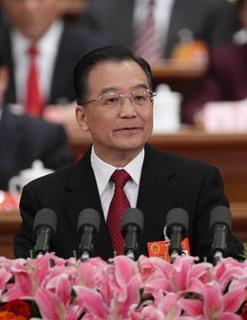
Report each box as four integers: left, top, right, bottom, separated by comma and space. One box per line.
82, 0, 236, 63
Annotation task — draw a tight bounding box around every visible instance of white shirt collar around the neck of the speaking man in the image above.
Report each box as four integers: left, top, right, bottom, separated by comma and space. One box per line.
91, 147, 145, 196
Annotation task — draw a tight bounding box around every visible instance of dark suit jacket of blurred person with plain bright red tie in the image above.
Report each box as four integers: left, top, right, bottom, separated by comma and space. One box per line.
1, 24, 110, 105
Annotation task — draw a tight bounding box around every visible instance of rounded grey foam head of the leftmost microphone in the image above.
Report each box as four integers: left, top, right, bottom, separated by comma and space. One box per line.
33, 208, 57, 234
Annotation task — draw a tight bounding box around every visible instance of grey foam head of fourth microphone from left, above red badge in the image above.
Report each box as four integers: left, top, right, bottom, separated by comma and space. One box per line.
166, 208, 189, 238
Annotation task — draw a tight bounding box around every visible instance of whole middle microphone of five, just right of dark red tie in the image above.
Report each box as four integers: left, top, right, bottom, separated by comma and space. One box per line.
121, 208, 143, 260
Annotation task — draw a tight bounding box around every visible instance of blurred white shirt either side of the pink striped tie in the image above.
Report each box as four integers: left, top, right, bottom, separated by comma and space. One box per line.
133, 0, 174, 45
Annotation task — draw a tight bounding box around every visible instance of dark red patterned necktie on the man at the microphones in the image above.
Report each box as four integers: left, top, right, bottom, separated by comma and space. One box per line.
107, 170, 130, 255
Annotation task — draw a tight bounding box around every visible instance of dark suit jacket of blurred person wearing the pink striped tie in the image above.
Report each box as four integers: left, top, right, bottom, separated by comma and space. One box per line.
81, 0, 237, 58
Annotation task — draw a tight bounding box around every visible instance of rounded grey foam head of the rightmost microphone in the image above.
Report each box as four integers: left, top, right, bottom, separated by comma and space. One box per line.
209, 206, 232, 230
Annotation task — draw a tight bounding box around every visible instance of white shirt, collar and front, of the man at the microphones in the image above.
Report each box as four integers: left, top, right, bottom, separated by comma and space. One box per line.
91, 147, 144, 220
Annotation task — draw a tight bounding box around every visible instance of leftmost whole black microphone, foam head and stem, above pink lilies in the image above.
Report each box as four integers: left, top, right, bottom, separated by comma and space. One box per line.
33, 208, 57, 256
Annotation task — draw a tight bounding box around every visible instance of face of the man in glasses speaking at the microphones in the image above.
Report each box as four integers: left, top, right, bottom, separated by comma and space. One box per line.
77, 60, 153, 163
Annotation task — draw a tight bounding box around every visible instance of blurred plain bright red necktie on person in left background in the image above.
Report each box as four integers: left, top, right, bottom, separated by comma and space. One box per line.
26, 47, 43, 116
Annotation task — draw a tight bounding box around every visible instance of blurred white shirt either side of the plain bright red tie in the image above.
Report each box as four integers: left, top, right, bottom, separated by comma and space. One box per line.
11, 20, 63, 104
